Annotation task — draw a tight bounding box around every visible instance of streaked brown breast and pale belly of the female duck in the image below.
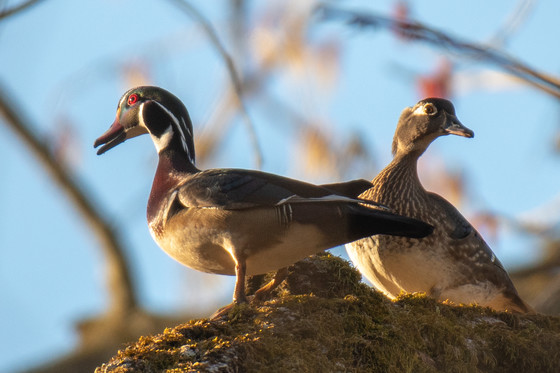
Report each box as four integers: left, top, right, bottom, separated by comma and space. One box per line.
347, 155, 512, 297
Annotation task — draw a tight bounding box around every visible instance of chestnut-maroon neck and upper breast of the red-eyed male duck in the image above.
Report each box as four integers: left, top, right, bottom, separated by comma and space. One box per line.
147, 151, 200, 222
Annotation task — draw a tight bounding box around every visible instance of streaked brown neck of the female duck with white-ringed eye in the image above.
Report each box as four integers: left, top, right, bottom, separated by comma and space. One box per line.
371, 149, 425, 213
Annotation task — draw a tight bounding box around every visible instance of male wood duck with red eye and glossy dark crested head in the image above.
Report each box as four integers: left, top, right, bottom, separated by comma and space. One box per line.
94, 86, 432, 314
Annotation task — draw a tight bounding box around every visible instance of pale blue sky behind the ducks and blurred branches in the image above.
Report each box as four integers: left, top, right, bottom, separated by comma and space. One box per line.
0, 0, 560, 371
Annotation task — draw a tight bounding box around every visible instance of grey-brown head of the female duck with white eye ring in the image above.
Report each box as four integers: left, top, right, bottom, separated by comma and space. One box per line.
392, 98, 474, 155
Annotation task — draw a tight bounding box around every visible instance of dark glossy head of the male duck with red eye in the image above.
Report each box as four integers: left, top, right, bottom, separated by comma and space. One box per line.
93, 86, 195, 164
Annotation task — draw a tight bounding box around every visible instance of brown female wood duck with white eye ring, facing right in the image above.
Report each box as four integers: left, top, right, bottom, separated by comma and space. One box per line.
346, 98, 532, 312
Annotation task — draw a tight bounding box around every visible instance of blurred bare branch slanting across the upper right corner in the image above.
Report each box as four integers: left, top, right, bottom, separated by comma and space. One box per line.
317, 5, 560, 99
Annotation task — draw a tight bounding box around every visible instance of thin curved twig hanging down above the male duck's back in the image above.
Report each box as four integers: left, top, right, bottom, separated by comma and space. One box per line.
165, 0, 263, 168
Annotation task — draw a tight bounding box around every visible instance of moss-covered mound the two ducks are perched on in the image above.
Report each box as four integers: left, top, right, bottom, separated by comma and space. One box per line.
96, 254, 560, 372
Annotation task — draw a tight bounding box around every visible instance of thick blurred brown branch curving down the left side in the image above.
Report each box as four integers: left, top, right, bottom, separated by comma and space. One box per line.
0, 78, 138, 315
